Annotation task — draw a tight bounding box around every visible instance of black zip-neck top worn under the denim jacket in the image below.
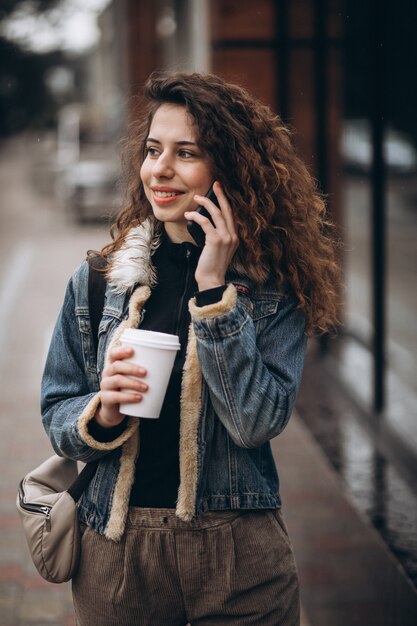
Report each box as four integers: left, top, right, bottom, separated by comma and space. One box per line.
89, 235, 226, 508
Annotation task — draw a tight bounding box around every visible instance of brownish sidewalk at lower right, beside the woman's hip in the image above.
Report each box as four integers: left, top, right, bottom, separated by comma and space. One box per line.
273, 415, 417, 626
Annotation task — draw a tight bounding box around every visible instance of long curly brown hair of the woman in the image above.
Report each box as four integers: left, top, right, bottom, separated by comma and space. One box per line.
102, 72, 340, 334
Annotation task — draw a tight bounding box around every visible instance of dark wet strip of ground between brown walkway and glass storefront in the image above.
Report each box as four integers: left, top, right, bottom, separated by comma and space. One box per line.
297, 350, 417, 588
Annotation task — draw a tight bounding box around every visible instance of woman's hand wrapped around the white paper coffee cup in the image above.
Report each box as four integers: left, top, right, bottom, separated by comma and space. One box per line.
95, 347, 148, 428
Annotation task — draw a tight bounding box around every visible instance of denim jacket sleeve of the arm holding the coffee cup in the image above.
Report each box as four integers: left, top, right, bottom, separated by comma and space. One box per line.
41, 270, 137, 462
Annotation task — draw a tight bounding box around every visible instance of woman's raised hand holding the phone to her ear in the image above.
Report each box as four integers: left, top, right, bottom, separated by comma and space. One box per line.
184, 181, 239, 291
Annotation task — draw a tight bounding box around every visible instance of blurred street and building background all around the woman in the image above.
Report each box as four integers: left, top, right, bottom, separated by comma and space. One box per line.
0, 0, 417, 626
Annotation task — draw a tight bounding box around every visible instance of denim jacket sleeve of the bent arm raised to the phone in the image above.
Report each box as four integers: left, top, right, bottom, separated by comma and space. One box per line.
190, 285, 306, 448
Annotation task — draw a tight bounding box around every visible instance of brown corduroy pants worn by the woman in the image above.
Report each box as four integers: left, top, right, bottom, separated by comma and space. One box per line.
73, 508, 300, 626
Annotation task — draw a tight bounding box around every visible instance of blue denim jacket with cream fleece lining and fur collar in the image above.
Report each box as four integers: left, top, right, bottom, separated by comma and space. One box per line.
41, 220, 306, 541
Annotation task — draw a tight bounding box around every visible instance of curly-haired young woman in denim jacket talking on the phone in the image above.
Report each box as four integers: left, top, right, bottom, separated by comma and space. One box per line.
42, 74, 338, 626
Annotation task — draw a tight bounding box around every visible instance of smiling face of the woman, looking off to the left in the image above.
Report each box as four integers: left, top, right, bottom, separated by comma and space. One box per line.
140, 104, 213, 242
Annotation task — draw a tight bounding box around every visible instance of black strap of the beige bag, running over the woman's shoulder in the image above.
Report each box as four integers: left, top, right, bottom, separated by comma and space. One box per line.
67, 256, 106, 502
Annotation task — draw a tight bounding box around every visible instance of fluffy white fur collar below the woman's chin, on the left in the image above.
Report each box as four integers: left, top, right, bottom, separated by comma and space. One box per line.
108, 218, 161, 294
